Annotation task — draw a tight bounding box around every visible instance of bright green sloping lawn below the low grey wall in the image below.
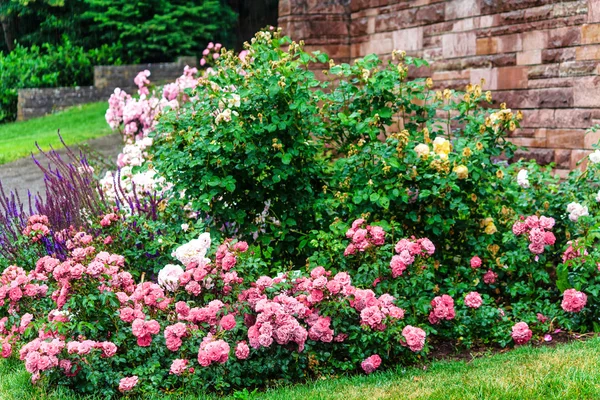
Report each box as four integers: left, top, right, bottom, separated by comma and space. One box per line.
0, 101, 111, 164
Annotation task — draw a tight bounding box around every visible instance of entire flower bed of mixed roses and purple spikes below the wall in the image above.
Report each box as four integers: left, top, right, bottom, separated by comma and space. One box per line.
0, 30, 600, 397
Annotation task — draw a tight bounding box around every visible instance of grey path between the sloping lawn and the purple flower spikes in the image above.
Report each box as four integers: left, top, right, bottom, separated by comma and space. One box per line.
0, 133, 123, 202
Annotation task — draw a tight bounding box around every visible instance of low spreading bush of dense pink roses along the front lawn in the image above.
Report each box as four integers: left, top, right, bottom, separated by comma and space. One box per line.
0, 219, 433, 393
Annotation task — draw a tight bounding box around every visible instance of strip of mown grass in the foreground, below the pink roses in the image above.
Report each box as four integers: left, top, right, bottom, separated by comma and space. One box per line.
0, 338, 600, 400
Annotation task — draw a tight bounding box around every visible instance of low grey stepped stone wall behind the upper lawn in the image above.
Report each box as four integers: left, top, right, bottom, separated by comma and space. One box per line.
17, 57, 197, 121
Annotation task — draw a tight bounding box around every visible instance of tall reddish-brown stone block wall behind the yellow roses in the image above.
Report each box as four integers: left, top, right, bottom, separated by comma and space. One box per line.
279, 0, 600, 175
